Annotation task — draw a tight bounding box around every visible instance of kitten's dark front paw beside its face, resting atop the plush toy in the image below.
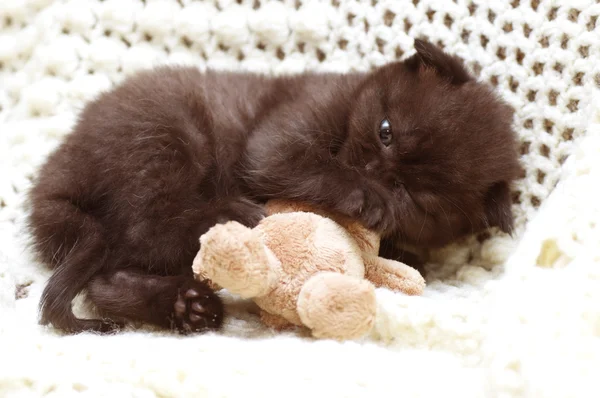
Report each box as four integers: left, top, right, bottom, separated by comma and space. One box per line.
339, 187, 394, 232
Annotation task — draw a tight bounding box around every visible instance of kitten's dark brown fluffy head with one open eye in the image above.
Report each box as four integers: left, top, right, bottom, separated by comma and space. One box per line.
339, 40, 521, 247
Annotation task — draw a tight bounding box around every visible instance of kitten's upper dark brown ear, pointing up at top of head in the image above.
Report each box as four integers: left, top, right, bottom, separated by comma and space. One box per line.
407, 39, 473, 85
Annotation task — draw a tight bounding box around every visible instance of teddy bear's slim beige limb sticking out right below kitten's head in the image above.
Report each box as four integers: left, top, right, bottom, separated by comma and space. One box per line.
363, 254, 425, 295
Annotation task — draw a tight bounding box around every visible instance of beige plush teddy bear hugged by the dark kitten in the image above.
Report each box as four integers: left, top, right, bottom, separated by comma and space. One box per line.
193, 201, 425, 340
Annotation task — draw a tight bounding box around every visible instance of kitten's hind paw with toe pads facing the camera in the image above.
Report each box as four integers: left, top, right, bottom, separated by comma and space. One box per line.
174, 279, 223, 334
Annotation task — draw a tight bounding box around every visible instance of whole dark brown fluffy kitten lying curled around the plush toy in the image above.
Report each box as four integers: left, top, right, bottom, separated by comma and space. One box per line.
30, 41, 519, 332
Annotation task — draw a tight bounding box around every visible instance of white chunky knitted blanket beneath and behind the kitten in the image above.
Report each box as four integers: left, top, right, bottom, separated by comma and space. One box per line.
0, 0, 600, 398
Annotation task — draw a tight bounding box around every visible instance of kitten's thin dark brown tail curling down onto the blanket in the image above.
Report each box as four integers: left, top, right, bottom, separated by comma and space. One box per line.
30, 199, 111, 333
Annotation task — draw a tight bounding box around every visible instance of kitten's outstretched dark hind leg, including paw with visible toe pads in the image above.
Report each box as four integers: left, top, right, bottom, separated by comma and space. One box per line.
87, 269, 223, 333
